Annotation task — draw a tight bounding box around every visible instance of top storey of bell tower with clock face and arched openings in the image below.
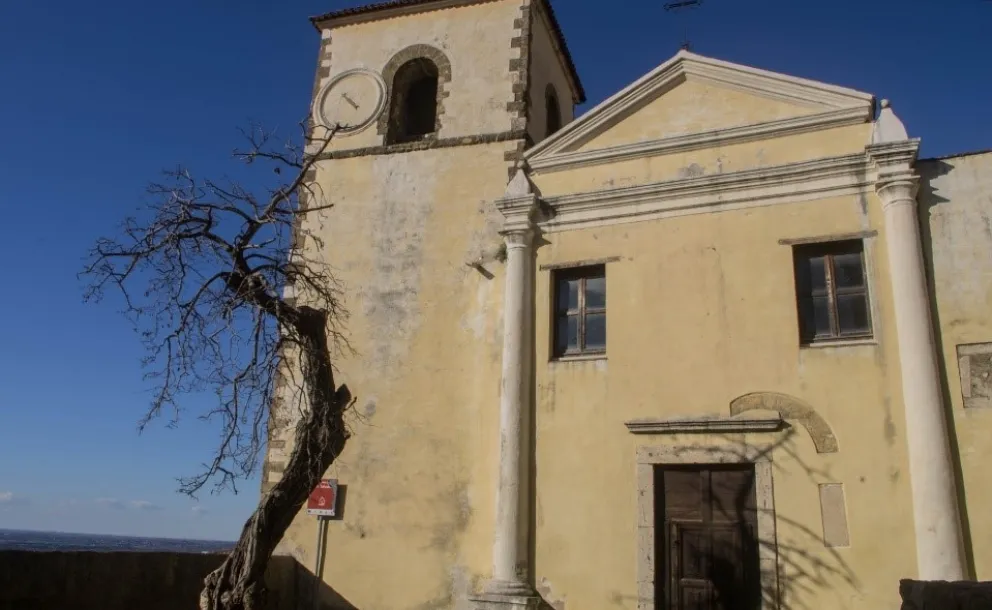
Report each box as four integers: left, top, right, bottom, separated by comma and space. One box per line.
312, 0, 585, 163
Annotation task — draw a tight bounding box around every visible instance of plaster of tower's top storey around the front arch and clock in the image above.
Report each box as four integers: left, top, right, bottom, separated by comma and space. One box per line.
329, 0, 521, 150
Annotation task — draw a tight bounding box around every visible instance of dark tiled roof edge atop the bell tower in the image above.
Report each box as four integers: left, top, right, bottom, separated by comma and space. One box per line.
310, 0, 586, 104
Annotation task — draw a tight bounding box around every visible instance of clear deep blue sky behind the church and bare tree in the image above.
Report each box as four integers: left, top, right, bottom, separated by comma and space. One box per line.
0, 0, 992, 539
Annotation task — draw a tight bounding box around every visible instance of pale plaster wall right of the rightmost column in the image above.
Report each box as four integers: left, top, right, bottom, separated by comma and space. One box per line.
918, 153, 992, 580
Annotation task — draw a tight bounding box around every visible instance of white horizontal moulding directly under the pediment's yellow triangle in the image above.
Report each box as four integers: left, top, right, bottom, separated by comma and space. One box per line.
528, 108, 866, 173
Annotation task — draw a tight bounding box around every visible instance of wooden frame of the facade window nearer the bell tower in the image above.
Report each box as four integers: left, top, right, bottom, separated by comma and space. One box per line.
551, 263, 609, 360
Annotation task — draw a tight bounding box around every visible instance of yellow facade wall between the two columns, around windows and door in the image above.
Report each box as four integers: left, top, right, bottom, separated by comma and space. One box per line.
536, 196, 916, 610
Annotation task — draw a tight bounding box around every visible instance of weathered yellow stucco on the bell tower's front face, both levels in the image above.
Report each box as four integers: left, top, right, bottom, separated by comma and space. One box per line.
267, 5, 544, 610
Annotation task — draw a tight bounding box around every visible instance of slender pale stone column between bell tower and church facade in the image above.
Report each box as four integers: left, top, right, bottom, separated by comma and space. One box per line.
473, 171, 540, 610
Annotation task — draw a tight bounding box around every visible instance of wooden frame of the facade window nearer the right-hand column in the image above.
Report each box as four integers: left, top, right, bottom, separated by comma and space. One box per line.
792, 239, 875, 346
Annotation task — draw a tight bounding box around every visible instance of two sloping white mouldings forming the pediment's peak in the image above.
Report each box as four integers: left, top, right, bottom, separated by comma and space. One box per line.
524, 50, 875, 163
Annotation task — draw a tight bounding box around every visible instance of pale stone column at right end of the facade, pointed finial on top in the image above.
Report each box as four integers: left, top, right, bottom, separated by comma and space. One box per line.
868, 102, 967, 580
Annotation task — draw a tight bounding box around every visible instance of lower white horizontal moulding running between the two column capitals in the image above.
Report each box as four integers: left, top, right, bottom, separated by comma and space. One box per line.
538, 153, 873, 233
